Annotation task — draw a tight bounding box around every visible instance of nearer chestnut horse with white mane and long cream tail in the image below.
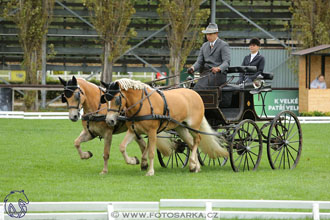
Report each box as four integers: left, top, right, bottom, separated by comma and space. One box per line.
102, 79, 228, 176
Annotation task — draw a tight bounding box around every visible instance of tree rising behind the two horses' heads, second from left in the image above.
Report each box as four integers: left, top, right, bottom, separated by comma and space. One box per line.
84, 0, 136, 83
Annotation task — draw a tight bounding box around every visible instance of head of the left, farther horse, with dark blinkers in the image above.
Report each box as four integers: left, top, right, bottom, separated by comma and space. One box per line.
59, 76, 85, 121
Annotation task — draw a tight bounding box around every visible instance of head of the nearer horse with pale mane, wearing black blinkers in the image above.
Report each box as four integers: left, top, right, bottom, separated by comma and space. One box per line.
101, 81, 126, 126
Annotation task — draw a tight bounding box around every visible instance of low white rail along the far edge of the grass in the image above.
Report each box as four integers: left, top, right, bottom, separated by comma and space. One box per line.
0, 111, 330, 124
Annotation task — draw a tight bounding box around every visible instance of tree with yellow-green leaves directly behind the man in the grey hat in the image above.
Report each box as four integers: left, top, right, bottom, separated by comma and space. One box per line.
157, 0, 210, 84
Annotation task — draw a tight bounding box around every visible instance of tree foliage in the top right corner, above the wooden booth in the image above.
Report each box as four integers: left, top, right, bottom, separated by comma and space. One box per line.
290, 0, 330, 48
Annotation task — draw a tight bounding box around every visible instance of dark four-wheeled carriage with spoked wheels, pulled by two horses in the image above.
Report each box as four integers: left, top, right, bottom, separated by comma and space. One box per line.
157, 66, 302, 172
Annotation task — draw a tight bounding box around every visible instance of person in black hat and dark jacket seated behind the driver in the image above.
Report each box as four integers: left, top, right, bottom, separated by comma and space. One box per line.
237, 38, 265, 84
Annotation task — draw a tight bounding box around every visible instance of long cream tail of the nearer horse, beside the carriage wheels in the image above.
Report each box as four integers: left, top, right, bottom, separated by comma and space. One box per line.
199, 117, 229, 158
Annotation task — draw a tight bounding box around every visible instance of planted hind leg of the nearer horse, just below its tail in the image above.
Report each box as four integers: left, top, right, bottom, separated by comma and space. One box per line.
175, 127, 200, 172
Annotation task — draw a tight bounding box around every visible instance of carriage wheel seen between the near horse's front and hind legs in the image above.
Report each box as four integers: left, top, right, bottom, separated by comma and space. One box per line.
157, 139, 190, 168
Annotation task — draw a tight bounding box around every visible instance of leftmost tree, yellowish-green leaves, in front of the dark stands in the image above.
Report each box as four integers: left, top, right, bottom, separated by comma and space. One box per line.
4, 0, 54, 110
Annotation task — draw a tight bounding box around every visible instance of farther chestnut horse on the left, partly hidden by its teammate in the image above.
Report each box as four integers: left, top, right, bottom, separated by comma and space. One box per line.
59, 76, 174, 174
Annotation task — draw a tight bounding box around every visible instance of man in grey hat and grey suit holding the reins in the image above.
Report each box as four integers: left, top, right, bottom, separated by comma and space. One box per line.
188, 23, 230, 89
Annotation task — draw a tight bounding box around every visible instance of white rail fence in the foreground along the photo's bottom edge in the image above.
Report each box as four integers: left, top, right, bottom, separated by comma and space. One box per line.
0, 199, 330, 220
